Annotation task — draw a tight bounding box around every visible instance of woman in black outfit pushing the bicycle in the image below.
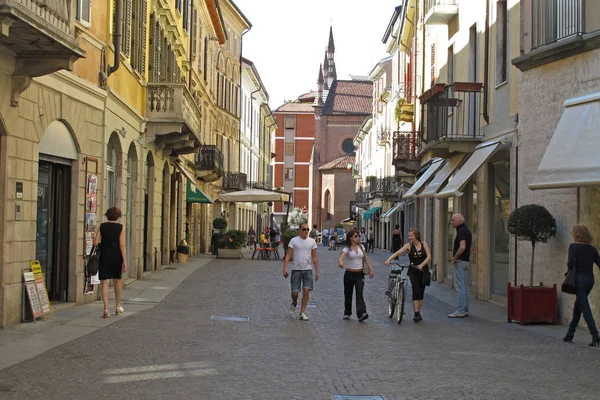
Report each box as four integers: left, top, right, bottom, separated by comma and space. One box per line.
385, 229, 431, 322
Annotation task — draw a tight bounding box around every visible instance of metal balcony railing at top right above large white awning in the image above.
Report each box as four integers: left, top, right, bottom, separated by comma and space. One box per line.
531, 0, 587, 49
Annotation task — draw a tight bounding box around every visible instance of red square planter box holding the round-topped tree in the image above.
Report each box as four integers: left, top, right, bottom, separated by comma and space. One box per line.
506, 283, 558, 325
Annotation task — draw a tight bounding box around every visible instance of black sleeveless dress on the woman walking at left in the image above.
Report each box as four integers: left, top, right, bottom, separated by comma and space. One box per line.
99, 222, 123, 281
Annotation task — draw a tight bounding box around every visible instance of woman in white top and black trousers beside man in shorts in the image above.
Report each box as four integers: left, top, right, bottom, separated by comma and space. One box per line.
338, 229, 373, 322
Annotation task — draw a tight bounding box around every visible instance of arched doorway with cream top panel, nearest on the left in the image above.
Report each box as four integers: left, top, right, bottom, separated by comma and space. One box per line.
36, 121, 79, 301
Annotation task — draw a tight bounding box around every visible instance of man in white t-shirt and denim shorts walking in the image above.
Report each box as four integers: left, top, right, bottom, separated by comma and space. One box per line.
283, 224, 319, 321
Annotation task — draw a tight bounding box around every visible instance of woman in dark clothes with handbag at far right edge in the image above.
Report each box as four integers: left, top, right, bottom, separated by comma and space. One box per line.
563, 225, 600, 347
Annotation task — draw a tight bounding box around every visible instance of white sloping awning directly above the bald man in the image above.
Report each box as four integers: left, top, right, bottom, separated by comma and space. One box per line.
435, 139, 510, 199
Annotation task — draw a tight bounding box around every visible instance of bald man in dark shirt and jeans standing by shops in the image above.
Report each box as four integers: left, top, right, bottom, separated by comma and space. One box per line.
448, 214, 472, 318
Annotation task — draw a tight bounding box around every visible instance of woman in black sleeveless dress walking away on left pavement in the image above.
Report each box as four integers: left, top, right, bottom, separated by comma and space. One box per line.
94, 207, 127, 318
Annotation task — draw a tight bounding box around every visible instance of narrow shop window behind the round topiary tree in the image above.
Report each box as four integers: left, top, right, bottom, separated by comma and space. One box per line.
491, 161, 510, 297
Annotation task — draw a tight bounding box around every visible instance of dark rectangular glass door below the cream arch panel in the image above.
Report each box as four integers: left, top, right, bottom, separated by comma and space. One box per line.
36, 159, 71, 301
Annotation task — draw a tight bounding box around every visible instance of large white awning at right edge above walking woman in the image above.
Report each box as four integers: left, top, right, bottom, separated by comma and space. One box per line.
528, 92, 600, 190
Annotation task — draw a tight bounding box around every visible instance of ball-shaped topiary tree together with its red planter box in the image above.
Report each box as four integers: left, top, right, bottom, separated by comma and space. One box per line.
507, 204, 558, 325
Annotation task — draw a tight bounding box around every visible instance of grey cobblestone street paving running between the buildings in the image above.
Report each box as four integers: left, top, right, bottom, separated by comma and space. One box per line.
0, 247, 600, 400
